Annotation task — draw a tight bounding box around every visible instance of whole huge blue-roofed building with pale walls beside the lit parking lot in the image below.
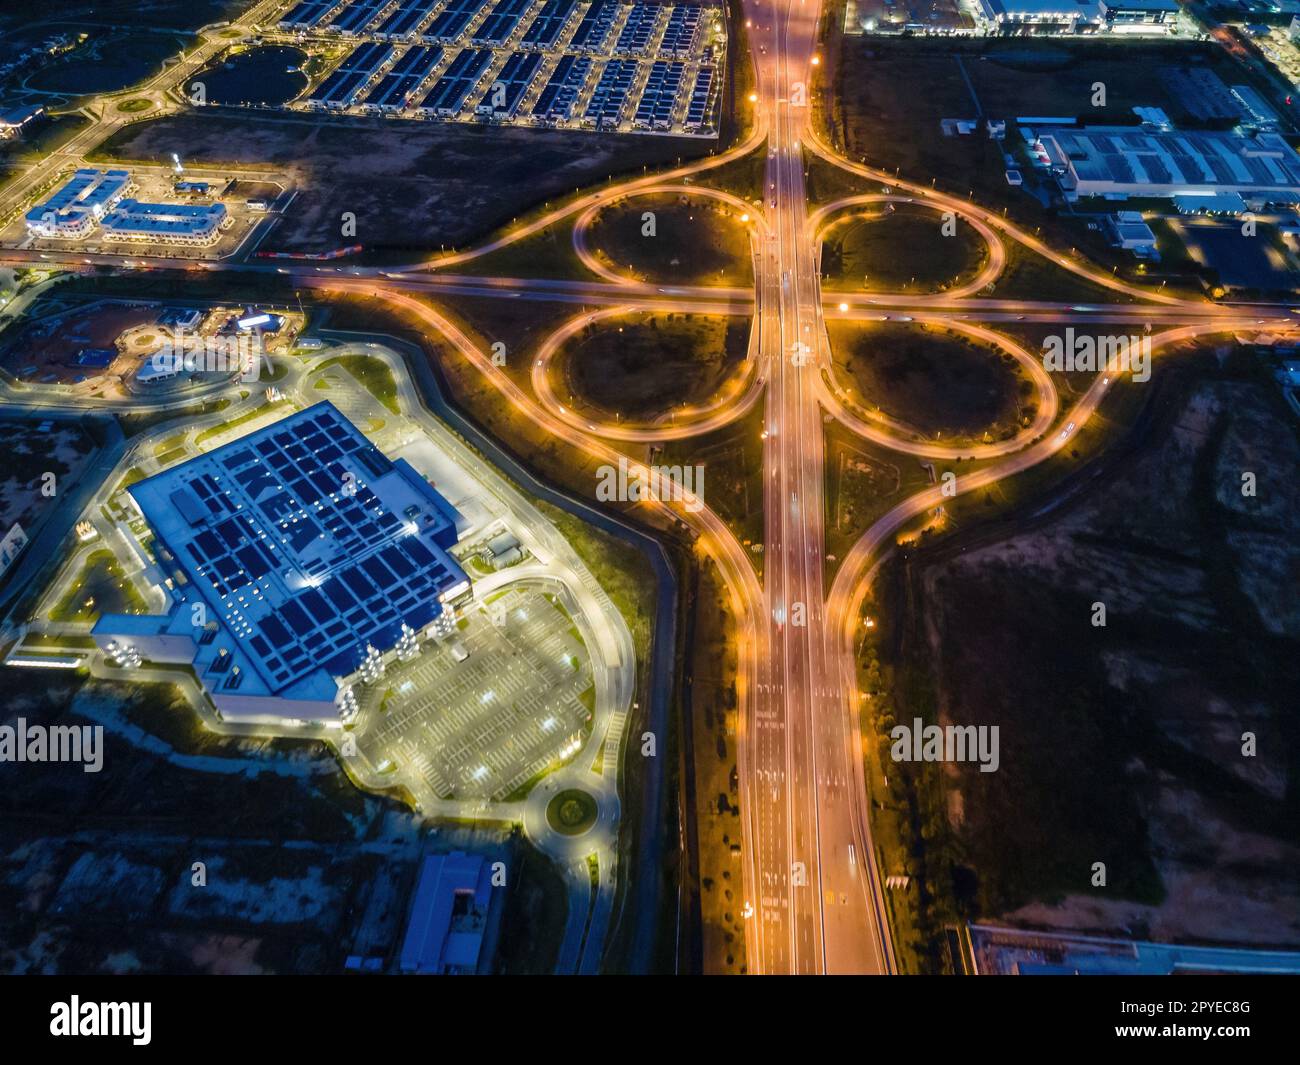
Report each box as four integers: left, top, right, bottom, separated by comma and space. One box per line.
92, 402, 469, 726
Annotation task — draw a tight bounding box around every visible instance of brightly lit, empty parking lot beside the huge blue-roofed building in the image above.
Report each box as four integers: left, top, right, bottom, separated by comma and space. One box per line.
356, 583, 592, 800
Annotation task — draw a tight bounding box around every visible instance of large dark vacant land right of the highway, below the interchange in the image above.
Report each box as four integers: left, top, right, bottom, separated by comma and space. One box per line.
900, 355, 1300, 947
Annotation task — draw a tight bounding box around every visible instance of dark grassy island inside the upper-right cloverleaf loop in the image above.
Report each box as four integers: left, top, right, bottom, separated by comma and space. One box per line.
822, 204, 988, 293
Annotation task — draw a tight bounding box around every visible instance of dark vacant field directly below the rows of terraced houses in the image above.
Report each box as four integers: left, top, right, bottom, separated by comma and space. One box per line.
99, 112, 711, 256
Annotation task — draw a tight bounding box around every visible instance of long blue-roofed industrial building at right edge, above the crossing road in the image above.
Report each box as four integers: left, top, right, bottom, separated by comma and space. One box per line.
1034, 126, 1300, 200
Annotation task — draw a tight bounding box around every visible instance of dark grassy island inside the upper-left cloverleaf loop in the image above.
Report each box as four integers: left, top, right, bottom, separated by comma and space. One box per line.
586, 192, 754, 286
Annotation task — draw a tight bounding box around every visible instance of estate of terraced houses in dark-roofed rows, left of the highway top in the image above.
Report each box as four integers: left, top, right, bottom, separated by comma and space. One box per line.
269, 0, 727, 137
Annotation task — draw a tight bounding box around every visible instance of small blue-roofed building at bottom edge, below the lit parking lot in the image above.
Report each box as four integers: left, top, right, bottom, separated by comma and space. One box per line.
399, 850, 493, 975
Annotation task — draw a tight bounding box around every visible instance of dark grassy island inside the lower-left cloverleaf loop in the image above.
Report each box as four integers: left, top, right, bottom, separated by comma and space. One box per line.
556, 313, 749, 419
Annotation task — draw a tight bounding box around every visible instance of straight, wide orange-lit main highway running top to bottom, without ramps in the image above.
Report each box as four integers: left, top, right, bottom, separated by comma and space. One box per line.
741, 0, 891, 974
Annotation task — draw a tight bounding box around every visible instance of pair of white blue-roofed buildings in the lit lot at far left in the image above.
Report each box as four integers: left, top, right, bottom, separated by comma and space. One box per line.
26, 166, 231, 244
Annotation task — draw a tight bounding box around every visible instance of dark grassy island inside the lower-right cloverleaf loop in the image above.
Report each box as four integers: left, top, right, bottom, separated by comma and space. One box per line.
828, 322, 1036, 437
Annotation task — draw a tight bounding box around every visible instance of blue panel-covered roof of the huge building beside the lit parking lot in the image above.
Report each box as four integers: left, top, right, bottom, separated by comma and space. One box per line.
131, 404, 465, 692
